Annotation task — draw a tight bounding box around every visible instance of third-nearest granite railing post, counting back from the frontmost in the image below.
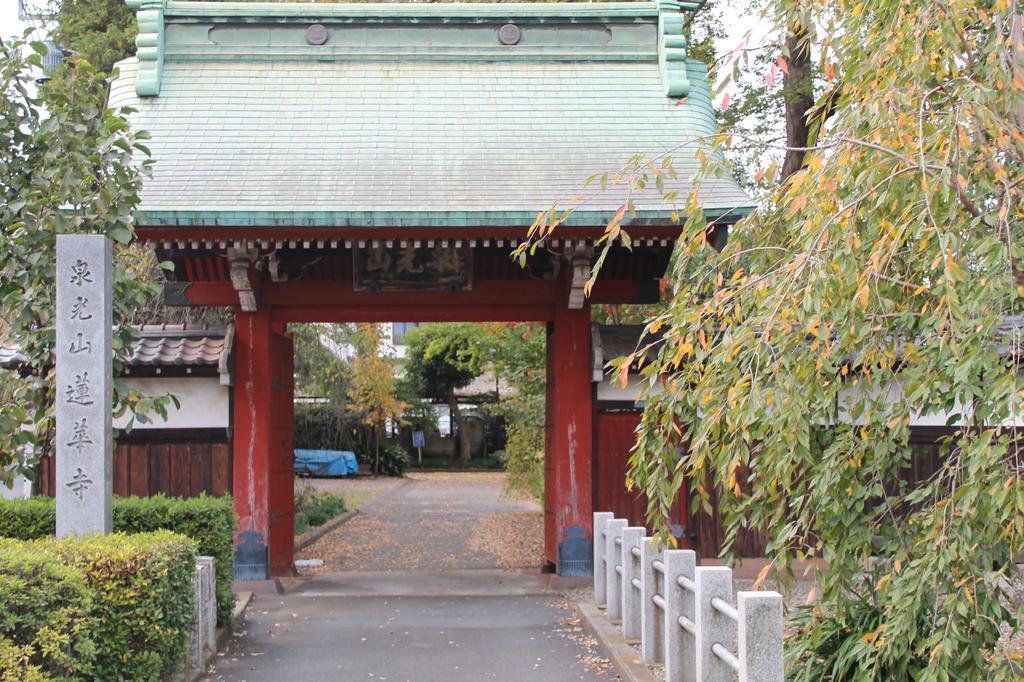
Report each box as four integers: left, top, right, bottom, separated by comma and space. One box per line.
663, 550, 700, 682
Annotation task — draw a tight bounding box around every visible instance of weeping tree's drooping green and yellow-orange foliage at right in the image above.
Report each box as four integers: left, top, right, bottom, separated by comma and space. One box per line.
577, 0, 1024, 680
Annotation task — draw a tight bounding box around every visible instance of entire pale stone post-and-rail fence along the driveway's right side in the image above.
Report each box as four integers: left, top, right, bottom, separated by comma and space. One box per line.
594, 512, 783, 682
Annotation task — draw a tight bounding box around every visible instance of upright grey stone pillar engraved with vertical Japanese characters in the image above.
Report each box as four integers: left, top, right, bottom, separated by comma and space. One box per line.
56, 235, 114, 536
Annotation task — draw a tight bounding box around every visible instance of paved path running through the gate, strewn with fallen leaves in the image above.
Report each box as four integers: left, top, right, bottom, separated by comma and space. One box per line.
208, 474, 616, 682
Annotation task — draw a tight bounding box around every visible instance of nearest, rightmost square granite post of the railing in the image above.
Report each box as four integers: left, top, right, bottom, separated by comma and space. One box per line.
736, 592, 785, 682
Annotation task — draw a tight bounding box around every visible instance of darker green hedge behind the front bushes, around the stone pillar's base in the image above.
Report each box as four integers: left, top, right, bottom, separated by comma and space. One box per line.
0, 495, 236, 625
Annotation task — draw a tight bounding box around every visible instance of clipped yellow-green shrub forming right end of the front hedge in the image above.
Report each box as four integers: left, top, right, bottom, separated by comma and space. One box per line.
43, 530, 197, 680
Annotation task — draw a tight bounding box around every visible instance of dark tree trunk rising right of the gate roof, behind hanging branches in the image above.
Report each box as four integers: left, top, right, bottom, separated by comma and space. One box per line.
780, 24, 814, 182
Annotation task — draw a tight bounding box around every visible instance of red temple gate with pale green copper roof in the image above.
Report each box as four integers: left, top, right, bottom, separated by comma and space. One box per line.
111, 0, 749, 573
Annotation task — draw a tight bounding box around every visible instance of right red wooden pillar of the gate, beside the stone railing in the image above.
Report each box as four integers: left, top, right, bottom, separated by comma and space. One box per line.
545, 291, 593, 574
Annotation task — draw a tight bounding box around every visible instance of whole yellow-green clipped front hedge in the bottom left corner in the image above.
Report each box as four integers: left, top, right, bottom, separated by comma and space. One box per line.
0, 530, 197, 680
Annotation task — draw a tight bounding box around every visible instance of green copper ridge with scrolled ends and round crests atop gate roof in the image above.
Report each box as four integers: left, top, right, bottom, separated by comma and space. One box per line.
127, 0, 700, 97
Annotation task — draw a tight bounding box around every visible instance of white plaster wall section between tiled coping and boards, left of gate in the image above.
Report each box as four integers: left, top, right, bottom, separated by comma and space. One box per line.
114, 377, 230, 429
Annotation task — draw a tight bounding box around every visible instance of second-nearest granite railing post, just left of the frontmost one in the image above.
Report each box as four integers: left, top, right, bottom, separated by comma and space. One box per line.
694, 566, 736, 682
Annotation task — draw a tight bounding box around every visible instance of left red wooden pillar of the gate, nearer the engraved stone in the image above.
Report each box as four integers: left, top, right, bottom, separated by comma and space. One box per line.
232, 306, 295, 579
